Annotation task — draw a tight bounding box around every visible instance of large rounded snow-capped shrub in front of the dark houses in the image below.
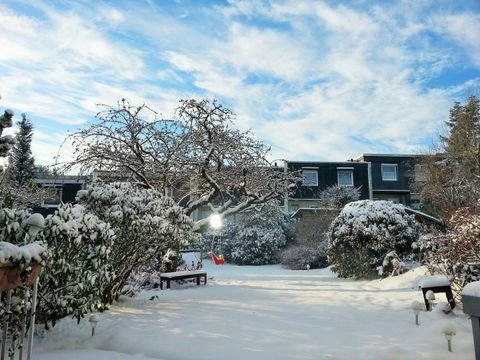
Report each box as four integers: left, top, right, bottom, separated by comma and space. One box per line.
327, 200, 418, 278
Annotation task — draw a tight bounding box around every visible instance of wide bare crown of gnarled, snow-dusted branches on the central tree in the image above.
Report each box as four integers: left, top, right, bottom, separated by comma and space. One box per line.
62, 99, 298, 227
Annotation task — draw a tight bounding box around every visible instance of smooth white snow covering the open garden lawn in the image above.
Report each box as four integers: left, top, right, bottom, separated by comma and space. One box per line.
34, 262, 474, 360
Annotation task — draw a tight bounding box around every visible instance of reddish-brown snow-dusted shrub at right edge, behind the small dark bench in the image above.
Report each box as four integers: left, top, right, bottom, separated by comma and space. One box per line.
417, 207, 480, 301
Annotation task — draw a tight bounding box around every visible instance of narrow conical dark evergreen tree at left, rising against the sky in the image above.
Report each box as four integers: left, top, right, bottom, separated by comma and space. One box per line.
10, 114, 35, 186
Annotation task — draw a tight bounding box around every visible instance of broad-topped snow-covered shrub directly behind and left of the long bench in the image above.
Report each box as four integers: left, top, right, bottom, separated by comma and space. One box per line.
77, 183, 194, 302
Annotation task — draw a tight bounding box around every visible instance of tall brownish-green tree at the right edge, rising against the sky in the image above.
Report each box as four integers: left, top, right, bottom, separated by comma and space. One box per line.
416, 96, 480, 218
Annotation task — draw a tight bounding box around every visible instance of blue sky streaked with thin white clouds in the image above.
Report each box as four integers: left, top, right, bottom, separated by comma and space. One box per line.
0, 0, 480, 164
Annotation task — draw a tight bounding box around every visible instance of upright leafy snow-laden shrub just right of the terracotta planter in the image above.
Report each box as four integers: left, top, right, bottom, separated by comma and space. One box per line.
37, 205, 115, 328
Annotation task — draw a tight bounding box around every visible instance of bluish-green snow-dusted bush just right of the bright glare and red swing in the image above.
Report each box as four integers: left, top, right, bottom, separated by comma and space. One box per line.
223, 202, 293, 265
